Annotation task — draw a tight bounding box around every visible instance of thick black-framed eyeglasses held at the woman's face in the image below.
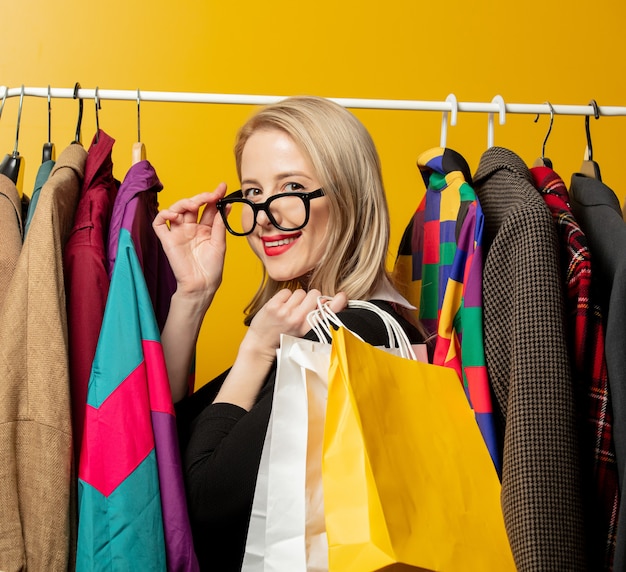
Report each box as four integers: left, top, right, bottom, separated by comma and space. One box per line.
216, 189, 324, 236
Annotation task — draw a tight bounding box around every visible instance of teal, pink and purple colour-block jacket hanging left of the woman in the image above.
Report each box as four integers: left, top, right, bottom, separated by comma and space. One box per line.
76, 228, 198, 572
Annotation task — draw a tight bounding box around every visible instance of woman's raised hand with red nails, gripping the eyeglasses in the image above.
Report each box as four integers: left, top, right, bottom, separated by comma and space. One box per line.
152, 183, 226, 303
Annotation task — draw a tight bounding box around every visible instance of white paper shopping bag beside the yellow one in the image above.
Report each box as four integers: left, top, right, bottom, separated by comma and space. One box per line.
242, 335, 330, 572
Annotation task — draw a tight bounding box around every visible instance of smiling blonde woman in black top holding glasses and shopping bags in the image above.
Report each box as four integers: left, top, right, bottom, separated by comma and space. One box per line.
154, 97, 422, 571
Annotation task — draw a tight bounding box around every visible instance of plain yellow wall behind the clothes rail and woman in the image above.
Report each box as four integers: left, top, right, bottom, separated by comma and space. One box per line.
0, 0, 626, 383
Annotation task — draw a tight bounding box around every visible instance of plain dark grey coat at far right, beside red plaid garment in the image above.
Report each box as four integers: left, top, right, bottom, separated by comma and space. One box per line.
569, 173, 626, 570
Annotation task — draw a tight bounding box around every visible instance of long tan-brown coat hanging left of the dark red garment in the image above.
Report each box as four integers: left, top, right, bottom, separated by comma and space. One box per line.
0, 144, 87, 572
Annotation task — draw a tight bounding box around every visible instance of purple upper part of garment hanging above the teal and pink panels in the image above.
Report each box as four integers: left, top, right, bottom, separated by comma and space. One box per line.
108, 161, 176, 331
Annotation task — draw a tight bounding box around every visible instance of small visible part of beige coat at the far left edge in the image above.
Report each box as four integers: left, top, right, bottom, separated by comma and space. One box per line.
0, 175, 23, 308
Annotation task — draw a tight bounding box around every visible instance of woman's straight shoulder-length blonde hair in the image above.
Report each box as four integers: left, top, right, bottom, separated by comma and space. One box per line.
234, 97, 389, 324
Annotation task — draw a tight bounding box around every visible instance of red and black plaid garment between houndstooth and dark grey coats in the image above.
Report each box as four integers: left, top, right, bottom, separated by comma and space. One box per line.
531, 167, 619, 570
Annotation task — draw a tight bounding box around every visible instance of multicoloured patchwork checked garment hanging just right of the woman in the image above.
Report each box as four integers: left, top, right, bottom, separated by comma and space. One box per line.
394, 147, 501, 474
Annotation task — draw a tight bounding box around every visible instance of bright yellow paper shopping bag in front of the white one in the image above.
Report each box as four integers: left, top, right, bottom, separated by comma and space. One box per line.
322, 328, 515, 572
